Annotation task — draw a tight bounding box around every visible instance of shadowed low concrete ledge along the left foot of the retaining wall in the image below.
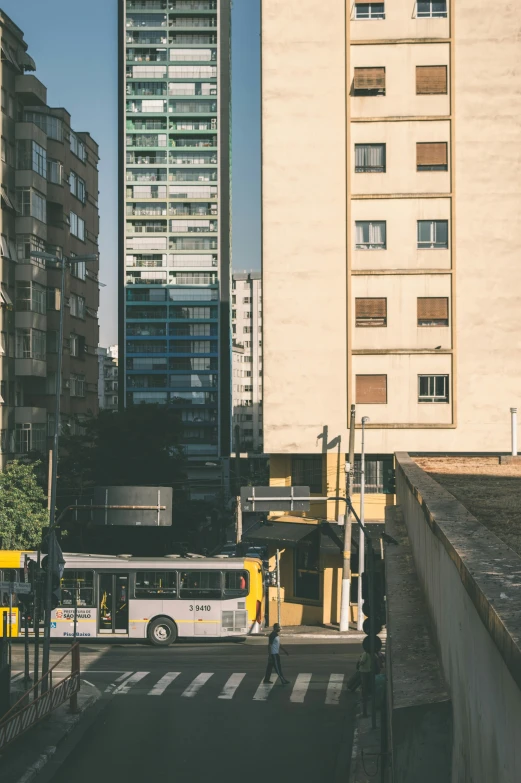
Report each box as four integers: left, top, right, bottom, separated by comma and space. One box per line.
385, 507, 452, 783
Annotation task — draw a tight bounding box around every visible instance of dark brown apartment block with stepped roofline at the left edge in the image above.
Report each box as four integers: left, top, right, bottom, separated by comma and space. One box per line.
0, 11, 99, 467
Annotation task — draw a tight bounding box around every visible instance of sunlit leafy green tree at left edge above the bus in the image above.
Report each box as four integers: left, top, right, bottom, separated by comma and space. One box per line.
0, 460, 49, 549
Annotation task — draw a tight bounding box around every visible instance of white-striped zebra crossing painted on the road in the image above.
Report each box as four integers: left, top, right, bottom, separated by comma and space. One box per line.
99, 672, 346, 706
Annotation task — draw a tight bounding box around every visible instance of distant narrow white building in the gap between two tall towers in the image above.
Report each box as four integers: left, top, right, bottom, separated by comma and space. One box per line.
232, 272, 263, 454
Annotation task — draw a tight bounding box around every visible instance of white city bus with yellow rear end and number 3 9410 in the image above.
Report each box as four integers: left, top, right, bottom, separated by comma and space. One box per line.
2, 553, 264, 645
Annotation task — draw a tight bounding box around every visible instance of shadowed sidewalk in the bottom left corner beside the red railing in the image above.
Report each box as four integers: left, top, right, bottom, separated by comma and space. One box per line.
0, 679, 101, 783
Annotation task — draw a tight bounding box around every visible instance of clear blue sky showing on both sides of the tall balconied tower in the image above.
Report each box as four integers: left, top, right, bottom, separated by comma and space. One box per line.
0, 0, 260, 346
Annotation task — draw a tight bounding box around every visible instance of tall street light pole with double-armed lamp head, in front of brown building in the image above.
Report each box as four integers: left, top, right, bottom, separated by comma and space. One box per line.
31, 251, 98, 690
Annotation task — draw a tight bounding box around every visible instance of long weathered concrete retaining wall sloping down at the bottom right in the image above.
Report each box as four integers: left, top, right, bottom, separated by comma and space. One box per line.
396, 453, 521, 783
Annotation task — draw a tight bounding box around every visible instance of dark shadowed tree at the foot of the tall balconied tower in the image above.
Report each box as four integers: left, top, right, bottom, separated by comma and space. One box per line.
58, 404, 184, 506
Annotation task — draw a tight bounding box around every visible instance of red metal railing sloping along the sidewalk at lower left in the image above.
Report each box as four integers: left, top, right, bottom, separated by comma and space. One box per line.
0, 642, 80, 751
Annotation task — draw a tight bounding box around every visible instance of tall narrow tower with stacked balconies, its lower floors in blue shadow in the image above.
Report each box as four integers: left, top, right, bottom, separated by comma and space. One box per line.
119, 0, 231, 478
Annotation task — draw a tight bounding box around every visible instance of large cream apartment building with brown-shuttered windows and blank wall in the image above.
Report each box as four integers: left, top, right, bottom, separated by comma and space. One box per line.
262, 0, 521, 516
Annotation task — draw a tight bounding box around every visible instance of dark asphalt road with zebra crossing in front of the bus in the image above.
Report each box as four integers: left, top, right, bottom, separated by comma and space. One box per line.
20, 639, 361, 783
